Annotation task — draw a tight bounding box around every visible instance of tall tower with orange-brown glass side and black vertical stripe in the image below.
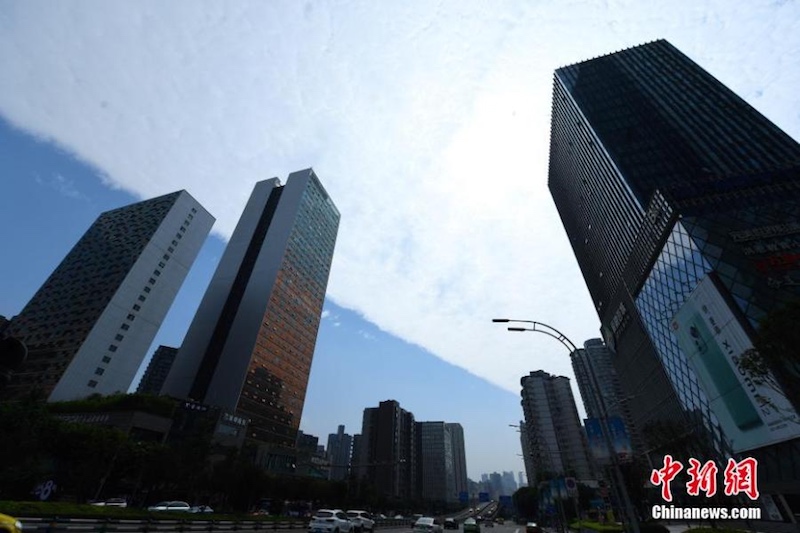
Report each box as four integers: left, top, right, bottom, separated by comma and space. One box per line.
162, 169, 339, 471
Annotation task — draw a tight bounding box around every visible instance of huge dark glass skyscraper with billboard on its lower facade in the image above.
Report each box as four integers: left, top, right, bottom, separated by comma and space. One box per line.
549, 41, 800, 507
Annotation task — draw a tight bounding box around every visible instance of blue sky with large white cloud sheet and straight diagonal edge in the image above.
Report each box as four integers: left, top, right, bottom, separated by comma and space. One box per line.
0, 0, 800, 479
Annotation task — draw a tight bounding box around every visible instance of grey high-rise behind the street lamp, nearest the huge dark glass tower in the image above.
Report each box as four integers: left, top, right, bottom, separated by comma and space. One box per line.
570, 339, 643, 453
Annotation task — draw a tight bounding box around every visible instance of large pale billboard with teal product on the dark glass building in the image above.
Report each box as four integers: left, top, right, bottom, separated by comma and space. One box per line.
672, 276, 800, 453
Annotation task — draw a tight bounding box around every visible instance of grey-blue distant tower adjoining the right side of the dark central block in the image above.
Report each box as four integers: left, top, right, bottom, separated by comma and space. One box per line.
416, 422, 458, 502
